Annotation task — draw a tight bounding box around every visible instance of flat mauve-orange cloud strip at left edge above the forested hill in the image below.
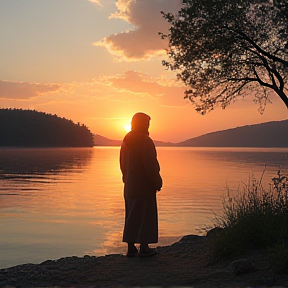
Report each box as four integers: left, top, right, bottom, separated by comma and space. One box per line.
0, 80, 60, 100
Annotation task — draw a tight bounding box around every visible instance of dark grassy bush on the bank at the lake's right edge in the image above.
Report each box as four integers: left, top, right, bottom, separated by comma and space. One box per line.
209, 171, 288, 262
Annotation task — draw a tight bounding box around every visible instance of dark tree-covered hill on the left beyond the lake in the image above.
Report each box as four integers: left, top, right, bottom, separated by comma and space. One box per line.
0, 109, 93, 147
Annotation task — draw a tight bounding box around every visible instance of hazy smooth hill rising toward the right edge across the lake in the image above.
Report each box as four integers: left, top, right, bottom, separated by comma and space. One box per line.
178, 120, 288, 147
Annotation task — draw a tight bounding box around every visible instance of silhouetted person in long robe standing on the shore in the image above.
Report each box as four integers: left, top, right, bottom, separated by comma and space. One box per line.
120, 113, 162, 257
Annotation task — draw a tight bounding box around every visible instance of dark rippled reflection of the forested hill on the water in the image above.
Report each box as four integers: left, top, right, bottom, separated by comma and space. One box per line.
0, 148, 93, 195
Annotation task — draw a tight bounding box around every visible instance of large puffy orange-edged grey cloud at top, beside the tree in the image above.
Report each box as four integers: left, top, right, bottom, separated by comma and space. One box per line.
94, 0, 182, 61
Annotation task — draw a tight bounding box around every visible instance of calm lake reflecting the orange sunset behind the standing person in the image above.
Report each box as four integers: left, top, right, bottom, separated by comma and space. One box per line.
0, 147, 288, 268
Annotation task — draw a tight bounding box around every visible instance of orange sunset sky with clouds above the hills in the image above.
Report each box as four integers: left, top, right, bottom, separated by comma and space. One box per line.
0, 0, 288, 142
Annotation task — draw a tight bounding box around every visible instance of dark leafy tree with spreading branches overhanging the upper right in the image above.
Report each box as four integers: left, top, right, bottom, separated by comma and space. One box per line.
160, 0, 288, 113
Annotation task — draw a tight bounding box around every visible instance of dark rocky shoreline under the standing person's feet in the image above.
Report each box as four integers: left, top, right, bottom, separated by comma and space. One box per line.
0, 235, 288, 288
